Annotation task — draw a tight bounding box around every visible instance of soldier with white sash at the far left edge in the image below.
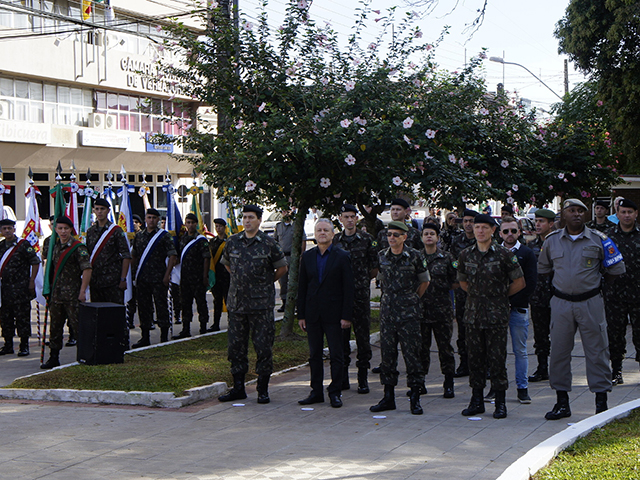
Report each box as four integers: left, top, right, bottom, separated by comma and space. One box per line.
0, 219, 40, 357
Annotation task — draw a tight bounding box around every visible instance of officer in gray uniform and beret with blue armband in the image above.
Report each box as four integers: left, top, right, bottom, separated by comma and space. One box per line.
538, 198, 625, 420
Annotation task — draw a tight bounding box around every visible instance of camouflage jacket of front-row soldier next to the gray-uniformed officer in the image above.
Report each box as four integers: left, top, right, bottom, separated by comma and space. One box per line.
458, 242, 524, 327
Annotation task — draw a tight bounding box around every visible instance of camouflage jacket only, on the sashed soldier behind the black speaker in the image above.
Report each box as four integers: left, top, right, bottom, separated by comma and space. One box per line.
86, 221, 131, 288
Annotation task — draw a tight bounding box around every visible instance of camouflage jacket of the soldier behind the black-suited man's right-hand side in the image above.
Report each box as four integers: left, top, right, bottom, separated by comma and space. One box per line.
333, 230, 378, 297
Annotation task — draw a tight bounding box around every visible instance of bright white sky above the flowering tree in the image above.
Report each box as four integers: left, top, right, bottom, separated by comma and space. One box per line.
238, 0, 584, 110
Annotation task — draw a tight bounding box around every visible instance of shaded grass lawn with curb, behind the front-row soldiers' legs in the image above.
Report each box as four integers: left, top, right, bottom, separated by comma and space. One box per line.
6, 310, 379, 395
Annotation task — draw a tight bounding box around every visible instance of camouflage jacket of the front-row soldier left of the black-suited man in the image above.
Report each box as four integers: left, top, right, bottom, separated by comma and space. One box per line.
221, 231, 287, 313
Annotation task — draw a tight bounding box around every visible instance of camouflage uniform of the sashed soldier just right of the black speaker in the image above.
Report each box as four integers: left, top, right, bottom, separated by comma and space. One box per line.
131, 228, 177, 334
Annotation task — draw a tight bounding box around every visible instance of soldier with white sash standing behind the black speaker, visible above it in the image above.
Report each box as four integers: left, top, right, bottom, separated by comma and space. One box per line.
86, 198, 131, 305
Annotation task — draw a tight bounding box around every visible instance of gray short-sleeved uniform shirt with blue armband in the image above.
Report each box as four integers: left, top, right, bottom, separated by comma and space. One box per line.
538, 227, 625, 295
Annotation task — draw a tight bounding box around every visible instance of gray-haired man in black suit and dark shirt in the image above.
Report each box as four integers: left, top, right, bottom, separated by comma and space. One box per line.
298, 218, 354, 408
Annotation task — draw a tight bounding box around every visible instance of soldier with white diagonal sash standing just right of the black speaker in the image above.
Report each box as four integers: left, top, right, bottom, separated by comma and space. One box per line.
131, 208, 177, 348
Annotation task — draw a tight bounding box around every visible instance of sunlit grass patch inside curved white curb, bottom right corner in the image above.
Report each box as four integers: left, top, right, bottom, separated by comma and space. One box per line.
533, 409, 640, 480
